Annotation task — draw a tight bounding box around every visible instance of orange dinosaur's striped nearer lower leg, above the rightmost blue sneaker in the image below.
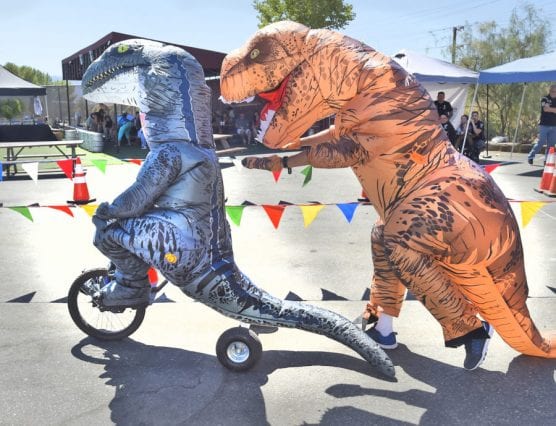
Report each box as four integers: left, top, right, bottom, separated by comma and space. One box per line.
385, 237, 487, 347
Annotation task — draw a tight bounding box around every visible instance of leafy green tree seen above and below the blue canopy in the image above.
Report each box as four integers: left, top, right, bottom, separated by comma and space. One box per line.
456, 4, 551, 142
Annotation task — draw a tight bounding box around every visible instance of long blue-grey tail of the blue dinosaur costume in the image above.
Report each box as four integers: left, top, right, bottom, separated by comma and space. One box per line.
180, 262, 395, 377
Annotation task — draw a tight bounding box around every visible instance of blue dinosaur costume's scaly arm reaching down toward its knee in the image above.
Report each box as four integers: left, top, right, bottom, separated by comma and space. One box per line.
107, 148, 182, 218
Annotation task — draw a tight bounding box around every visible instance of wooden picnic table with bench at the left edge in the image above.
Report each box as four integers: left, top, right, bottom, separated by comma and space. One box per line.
0, 140, 83, 177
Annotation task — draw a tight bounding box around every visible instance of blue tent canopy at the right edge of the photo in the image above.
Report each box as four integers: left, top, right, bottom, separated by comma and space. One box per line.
479, 52, 556, 84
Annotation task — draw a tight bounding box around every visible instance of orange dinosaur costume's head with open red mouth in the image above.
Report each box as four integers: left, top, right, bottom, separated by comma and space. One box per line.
220, 21, 337, 148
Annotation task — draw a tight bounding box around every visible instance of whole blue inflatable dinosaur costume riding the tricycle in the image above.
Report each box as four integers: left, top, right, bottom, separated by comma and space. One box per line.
83, 40, 394, 376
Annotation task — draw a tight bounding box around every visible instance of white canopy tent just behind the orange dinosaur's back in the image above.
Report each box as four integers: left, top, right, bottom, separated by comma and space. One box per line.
393, 50, 479, 126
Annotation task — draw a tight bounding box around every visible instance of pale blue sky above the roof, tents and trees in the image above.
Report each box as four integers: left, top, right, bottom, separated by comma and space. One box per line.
0, 0, 556, 79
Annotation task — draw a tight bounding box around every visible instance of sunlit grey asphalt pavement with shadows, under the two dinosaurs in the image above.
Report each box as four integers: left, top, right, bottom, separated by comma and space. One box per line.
0, 152, 556, 425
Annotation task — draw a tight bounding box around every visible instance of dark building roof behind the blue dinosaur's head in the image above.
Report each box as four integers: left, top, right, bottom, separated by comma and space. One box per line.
62, 32, 226, 80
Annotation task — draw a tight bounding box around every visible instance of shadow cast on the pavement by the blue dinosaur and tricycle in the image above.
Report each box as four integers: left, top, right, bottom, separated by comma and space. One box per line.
71, 337, 391, 425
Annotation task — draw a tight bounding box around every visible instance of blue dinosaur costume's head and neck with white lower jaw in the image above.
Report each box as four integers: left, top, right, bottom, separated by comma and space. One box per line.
82, 39, 214, 148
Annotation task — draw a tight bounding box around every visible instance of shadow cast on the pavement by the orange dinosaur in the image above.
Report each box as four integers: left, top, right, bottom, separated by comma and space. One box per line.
326, 345, 556, 425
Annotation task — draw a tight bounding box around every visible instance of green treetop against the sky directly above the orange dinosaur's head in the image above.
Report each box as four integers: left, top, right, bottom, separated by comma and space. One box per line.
253, 0, 355, 29
